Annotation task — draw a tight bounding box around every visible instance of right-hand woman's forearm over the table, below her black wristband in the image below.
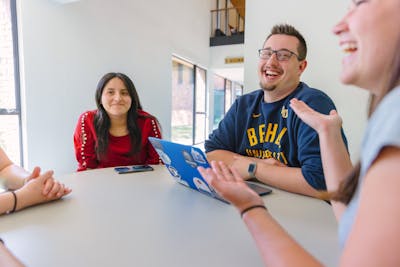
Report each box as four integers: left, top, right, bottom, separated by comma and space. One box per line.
243, 209, 322, 267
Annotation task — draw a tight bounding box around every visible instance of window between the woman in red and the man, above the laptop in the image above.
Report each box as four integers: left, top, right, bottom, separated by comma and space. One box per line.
171, 57, 207, 145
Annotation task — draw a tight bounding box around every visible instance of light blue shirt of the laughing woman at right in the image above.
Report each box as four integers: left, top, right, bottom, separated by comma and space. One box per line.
339, 86, 400, 249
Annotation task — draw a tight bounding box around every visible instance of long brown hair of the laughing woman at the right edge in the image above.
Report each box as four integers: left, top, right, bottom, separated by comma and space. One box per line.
330, 38, 400, 204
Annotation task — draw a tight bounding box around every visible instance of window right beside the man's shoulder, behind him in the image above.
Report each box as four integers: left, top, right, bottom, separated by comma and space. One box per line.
213, 75, 243, 129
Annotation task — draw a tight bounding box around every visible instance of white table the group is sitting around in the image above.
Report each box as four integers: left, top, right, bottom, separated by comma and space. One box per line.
0, 166, 339, 267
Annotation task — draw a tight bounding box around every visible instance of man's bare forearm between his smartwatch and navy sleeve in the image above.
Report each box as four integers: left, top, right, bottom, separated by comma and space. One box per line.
255, 163, 318, 197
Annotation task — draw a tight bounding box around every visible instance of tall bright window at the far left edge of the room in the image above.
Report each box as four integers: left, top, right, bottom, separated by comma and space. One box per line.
0, 0, 23, 165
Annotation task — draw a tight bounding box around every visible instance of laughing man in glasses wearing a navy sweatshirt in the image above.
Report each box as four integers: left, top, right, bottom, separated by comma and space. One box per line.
205, 24, 347, 196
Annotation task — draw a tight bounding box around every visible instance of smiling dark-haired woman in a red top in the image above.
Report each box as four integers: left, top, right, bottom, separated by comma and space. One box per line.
74, 72, 161, 171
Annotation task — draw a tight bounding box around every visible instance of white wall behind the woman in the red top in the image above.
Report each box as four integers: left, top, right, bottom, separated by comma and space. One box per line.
18, 0, 211, 175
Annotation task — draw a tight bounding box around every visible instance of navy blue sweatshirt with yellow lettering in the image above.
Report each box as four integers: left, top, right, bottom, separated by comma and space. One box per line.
205, 82, 347, 190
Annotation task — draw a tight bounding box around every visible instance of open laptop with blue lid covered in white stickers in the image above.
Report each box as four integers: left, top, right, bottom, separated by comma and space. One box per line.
149, 137, 272, 202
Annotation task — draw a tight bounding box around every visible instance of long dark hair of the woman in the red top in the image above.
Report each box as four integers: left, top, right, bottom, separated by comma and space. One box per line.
94, 72, 142, 159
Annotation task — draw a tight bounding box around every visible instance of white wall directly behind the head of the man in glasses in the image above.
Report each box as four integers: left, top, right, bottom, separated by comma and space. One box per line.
244, 0, 368, 161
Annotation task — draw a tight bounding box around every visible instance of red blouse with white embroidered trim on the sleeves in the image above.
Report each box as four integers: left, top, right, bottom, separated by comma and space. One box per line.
74, 110, 162, 171
